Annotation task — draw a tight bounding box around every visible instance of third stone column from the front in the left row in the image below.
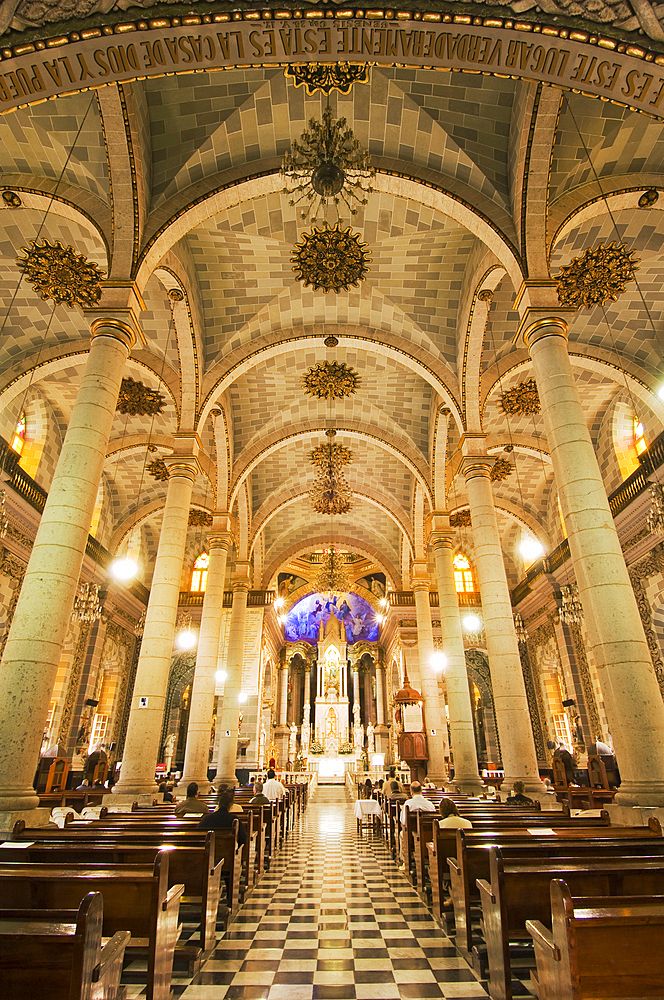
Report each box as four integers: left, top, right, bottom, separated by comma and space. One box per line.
178, 514, 232, 792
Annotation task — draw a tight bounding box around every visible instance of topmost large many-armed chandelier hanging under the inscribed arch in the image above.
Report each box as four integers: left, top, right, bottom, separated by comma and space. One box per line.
281, 104, 376, 222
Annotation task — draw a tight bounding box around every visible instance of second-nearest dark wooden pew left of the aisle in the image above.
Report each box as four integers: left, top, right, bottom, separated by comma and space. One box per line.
0, 851, 184, 1000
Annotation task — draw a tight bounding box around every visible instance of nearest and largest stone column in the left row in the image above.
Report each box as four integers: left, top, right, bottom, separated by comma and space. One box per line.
0, 298, 142, 829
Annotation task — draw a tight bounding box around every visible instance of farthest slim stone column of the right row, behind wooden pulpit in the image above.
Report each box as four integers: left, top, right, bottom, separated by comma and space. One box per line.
411, 563, 448, 782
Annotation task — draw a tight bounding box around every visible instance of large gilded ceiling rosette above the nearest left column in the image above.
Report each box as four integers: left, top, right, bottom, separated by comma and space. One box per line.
16, 240, 104, 308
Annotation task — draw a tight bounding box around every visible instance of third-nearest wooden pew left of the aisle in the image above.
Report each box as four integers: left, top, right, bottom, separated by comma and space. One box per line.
0, 830, 223, 963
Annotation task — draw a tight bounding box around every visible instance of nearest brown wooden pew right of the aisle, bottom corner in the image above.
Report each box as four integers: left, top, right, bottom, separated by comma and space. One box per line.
526, 879, 664, 1000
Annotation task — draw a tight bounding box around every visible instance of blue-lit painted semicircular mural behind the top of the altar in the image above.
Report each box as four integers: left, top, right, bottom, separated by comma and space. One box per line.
284, 593, 379, 646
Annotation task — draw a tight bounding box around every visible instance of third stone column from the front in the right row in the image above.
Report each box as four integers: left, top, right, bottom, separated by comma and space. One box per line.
431, 513, 484, 795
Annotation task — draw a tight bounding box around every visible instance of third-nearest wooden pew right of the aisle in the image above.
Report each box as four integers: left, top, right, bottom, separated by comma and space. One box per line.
448, 819, 662, 962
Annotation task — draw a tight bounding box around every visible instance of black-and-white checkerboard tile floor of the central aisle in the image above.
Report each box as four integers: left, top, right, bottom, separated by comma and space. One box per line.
129, 787, 529, 1000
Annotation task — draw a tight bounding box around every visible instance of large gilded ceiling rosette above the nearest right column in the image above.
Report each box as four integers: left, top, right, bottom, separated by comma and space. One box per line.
557, 243, 638, 309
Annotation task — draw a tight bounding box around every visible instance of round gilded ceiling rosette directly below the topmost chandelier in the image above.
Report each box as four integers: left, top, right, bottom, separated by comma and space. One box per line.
291, 223, 371, 292
